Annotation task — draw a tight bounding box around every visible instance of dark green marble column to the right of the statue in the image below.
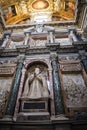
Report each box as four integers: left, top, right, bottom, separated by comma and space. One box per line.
51, 54, 64, 115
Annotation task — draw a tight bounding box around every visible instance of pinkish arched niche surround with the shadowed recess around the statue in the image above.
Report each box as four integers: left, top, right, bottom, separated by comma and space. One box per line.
14, 58, 55, 120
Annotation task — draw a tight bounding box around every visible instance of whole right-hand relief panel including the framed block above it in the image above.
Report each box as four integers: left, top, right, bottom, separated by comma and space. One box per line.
60, 63, 87, 116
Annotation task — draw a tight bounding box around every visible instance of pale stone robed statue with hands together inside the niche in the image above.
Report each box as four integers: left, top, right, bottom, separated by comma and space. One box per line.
22, 68, 49, 99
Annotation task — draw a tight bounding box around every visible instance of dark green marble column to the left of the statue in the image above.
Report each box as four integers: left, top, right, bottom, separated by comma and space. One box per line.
5, 62, 23, 116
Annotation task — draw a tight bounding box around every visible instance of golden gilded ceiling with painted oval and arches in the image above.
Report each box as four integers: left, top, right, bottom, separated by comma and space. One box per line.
0, 0, 77, 25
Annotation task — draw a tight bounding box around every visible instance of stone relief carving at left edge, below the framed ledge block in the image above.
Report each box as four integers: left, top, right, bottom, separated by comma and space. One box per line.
0, 78, 12, 118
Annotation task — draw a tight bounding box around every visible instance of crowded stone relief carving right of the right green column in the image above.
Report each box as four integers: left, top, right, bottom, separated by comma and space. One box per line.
63, 74, 87, 107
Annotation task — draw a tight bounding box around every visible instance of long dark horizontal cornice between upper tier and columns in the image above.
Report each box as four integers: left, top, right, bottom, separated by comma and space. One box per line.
0, 43, 87, 57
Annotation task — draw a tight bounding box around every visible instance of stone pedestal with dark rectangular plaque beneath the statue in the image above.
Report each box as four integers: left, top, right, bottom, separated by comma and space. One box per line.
17, 98, 50, 121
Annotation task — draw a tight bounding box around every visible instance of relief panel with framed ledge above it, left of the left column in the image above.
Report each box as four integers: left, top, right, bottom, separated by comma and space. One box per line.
0, 65, 16, 118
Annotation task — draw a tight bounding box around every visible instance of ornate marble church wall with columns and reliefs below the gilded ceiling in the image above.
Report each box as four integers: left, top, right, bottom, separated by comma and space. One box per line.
0, 0, 87, 130
